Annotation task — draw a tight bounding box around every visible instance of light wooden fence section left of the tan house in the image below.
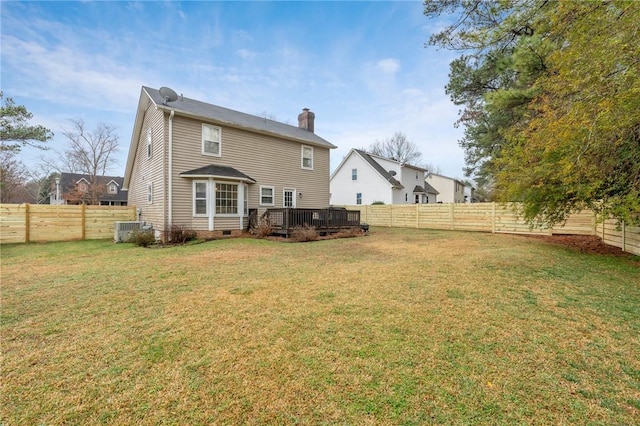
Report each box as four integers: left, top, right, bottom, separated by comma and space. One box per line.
0, 204, 136, 244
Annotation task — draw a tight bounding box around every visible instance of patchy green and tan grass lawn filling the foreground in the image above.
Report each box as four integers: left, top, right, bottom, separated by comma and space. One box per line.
0, 228, 640, 426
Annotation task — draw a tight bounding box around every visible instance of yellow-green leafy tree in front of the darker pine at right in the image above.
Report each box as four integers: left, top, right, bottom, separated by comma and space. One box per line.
497, 1, 640, 222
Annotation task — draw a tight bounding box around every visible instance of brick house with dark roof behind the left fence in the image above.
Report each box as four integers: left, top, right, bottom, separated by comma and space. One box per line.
50, 173, 127, 206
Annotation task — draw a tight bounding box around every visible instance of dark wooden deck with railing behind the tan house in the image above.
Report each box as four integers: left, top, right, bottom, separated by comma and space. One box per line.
254, 208, 364, 236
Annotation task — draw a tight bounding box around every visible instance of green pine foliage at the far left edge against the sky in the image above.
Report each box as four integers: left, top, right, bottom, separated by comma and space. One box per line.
0, 91, 53, 152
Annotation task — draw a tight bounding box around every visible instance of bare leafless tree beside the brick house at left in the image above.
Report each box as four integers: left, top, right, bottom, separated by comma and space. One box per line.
61, 120, 118, 204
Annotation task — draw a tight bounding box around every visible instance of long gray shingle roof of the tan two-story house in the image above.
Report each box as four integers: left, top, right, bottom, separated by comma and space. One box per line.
142, 86, 336, 148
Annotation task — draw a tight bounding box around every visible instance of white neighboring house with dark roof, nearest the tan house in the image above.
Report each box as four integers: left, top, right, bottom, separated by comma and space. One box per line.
329, 149, 437, 206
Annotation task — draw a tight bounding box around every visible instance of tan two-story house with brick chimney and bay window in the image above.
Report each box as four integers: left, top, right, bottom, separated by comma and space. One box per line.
124, 86, 335, 238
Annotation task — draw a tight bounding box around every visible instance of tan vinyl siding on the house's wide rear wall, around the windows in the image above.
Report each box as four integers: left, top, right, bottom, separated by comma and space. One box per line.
170, 116, 329, 230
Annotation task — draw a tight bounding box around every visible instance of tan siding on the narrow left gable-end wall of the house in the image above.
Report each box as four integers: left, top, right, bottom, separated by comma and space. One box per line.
128, 103, 166, 231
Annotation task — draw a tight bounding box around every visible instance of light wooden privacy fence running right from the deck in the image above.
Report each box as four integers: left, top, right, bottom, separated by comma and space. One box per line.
345, 203, 640, 255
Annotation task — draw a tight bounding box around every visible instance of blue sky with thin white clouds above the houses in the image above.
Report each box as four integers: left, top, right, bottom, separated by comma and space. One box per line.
0, 1, 464, 177
